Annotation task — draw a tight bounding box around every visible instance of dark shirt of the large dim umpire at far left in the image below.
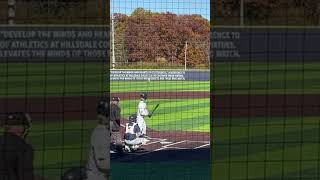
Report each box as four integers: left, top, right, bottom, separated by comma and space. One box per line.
0, 133, 34, 180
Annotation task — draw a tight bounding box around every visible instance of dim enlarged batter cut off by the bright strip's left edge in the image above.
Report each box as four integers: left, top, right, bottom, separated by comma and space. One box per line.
87, 99, 110, 180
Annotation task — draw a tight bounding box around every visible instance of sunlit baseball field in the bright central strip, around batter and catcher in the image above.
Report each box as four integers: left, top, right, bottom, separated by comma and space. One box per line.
111, 69, 210, 180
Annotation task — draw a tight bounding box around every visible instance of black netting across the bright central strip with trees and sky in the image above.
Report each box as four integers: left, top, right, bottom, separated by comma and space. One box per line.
110, 0, 210, 180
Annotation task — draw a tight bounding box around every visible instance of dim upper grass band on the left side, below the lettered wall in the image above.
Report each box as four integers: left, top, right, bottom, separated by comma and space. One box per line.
0, 63, 106, 97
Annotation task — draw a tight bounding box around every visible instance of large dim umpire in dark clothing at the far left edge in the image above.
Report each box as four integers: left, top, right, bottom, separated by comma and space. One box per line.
0, 112, 36, 180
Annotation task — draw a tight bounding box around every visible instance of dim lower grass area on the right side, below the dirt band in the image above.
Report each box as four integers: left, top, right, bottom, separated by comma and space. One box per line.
212, 117, 320, 180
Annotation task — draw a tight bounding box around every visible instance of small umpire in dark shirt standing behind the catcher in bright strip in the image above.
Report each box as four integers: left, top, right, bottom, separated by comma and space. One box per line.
110, 97, 123, 153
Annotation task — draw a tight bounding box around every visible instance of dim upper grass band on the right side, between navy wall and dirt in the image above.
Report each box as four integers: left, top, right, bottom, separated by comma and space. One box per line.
213, 63, 320, 94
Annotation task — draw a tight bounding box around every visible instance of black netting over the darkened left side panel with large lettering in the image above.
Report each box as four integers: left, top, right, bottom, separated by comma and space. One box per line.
0, 0, 110, 180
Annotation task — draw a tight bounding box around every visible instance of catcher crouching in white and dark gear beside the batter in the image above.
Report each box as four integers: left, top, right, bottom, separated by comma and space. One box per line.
124, 114, 146, 152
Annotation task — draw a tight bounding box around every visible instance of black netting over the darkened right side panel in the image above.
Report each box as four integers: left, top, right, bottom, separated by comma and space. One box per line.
211, 0, 320, 180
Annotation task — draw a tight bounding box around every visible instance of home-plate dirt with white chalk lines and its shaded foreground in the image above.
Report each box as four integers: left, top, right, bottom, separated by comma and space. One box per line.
111, 119, 210, 163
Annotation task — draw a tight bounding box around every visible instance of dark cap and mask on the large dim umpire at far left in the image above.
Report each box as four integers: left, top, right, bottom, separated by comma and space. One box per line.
5, 112, 32, 137
